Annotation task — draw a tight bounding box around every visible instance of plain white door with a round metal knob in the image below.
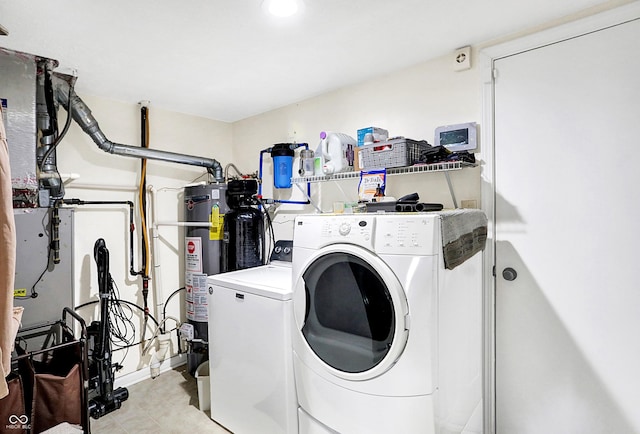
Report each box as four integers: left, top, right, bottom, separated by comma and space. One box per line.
494, 15, 640, 434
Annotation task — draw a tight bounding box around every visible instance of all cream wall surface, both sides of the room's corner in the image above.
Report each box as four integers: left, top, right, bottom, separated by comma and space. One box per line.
53, 56, 481, 375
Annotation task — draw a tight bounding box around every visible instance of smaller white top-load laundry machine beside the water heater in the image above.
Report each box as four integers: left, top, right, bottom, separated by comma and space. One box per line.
208, 241, 298, 434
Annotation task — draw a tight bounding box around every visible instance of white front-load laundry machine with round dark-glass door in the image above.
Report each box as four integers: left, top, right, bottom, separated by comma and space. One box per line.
292, 213, 482, 434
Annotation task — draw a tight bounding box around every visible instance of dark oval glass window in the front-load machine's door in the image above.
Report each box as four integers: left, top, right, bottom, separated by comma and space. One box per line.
302, 252, 396, 373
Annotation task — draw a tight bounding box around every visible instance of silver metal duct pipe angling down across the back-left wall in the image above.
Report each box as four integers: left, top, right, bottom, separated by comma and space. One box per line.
56, 80, 224, 182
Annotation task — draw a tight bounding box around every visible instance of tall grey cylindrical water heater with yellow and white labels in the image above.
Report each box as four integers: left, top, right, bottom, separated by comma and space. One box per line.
184, 184, 229, 375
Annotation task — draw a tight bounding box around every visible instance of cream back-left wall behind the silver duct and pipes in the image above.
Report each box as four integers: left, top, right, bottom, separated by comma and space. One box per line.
58, 95, 232, 374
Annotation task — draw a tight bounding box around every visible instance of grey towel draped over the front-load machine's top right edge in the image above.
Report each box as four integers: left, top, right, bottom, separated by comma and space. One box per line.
439, 209, 488, 270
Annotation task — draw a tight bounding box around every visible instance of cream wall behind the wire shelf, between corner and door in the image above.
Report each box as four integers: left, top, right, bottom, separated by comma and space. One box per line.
233, 52, 482, 238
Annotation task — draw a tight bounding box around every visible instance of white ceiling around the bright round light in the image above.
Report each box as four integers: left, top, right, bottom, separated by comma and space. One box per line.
0, 0, 607, 122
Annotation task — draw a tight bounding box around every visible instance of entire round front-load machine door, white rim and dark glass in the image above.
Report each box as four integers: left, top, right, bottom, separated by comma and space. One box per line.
294, 244, 408, 380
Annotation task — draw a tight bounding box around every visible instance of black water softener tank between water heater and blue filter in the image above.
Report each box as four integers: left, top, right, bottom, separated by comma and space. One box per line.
222, 179, 265, 271
